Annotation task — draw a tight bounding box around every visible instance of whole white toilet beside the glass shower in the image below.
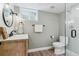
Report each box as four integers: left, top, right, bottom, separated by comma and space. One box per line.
52, 36, 68, 55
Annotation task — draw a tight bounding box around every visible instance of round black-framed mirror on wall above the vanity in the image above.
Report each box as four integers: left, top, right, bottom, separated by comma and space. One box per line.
2, 4, 13, 27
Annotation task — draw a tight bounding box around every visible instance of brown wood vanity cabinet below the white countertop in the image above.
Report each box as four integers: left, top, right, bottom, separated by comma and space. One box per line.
0, 40, 28, 56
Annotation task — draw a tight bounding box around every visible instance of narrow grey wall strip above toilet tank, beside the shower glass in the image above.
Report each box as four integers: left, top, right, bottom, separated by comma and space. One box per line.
59, 12, 66, 36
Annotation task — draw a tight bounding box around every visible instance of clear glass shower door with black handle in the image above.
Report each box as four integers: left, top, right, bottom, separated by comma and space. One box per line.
66, 3, 79, 56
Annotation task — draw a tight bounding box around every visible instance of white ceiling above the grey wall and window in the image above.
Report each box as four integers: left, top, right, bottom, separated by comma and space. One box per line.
13, 3, 65, 13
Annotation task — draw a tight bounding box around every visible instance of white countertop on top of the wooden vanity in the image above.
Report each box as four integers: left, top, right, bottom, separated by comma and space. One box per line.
0, 34, 29, 42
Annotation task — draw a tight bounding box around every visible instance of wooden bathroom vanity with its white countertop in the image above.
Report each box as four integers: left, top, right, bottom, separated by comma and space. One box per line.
0, 34, 29, 56
